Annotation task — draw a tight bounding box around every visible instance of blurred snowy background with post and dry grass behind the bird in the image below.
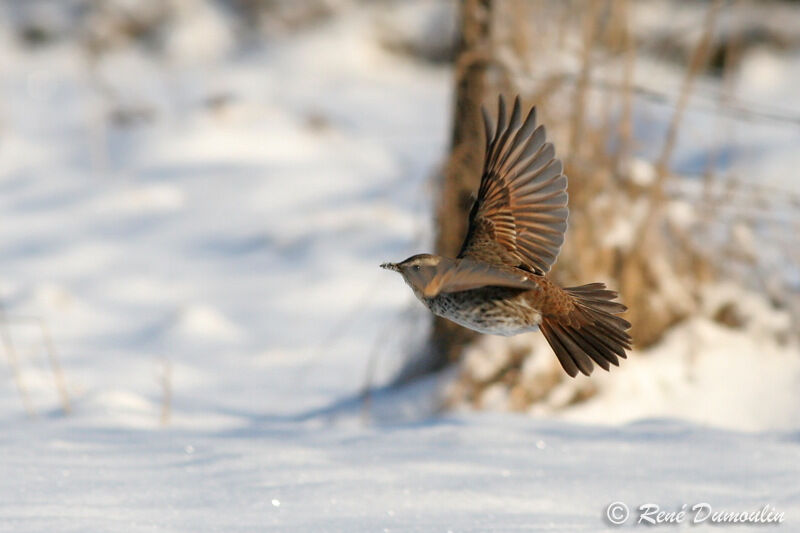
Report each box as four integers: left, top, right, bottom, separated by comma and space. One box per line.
0, 0, 800, 430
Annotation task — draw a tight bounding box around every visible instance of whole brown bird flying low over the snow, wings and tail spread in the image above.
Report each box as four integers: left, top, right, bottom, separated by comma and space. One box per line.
381, 96, 631, 377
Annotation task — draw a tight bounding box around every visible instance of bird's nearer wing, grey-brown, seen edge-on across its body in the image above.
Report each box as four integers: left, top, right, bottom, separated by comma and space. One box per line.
423, 259, 539, 298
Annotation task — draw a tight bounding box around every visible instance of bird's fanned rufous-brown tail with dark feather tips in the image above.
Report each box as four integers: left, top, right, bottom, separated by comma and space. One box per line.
540, 283, 631, 377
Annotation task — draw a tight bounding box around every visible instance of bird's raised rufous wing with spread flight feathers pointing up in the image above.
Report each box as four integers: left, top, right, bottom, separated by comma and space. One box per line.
459, 96, 569, 274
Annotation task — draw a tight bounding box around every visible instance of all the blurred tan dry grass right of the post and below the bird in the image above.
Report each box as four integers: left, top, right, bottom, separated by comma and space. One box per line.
447, 0, 800, 410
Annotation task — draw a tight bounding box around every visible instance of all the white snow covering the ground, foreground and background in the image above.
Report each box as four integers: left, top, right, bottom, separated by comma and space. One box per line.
0, 1, 800, 532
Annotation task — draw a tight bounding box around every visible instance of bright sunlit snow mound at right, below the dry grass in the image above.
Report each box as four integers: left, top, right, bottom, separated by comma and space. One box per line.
562, 319, 800, 431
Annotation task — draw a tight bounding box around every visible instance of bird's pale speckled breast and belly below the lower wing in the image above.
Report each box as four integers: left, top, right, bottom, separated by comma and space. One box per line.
422, 287, 542, 336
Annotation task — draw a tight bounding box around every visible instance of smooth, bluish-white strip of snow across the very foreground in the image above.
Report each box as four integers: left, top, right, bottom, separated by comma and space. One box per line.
0, 414, 800, 532
